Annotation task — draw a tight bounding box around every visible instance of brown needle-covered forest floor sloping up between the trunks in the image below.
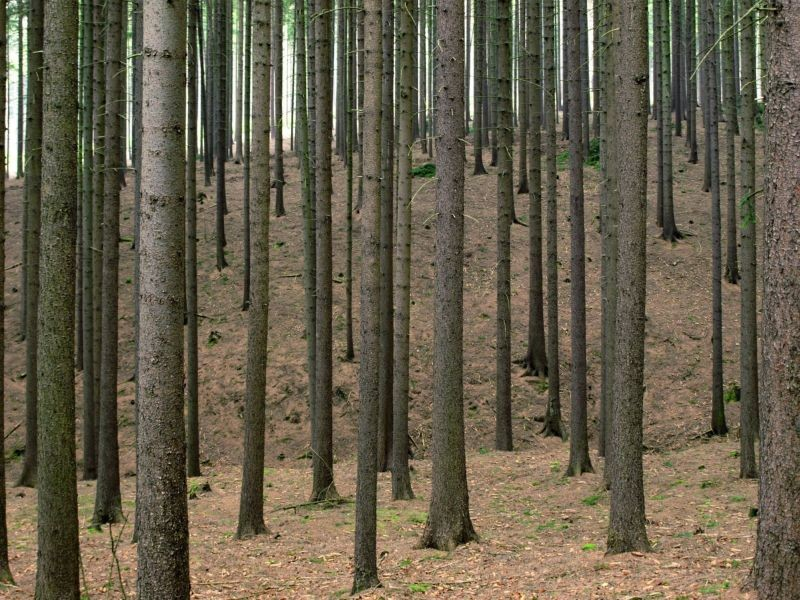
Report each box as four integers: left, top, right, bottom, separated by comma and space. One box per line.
0, 119, 756, 598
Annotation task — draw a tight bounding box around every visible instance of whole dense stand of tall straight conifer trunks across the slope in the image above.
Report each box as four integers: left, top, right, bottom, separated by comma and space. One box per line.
0, 0, 800, 598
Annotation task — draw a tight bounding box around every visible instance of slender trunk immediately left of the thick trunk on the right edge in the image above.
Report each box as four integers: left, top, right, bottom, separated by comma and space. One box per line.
739, 0, 758, 479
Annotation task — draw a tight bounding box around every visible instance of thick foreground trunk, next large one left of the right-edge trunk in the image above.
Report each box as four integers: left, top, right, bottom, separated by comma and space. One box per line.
607, 0, 650, 554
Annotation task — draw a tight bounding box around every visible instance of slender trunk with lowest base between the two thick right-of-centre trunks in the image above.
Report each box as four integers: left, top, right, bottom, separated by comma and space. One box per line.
566, 0, 593, 475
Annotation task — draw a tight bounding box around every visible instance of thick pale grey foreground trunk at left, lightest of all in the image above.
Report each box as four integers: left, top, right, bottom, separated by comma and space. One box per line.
136, 0, 190, 600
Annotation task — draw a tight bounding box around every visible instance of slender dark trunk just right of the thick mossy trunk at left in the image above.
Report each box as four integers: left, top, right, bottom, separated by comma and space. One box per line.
80, 0, 97, 480
